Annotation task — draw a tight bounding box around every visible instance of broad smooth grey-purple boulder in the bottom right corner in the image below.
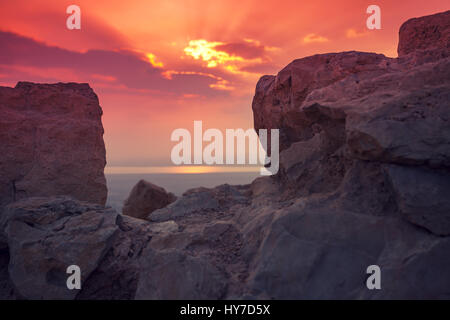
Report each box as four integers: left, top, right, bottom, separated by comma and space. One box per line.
244, 202, 450, 299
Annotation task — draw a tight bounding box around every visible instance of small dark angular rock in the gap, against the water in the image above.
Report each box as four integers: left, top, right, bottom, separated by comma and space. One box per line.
122, 180, 176, 218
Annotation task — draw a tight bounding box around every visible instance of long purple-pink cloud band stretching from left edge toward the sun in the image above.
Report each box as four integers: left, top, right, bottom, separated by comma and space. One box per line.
0, 32, 232, 96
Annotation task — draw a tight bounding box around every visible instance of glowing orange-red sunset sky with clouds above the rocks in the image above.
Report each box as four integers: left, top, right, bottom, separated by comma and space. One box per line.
0, 0, 450, 167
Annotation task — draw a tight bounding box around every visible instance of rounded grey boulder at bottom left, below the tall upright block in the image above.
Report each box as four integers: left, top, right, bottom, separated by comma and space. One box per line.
1, 196, 118, 299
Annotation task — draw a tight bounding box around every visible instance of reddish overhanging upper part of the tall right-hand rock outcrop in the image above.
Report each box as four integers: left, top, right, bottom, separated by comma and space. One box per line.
252, 11, 450, 166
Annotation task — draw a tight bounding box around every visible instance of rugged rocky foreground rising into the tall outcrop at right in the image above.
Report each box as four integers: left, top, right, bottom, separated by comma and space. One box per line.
0, 11, 450, 299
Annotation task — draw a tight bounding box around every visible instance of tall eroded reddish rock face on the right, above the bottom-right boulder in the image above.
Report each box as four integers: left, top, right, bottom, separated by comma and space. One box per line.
253, 11, 450, 235
